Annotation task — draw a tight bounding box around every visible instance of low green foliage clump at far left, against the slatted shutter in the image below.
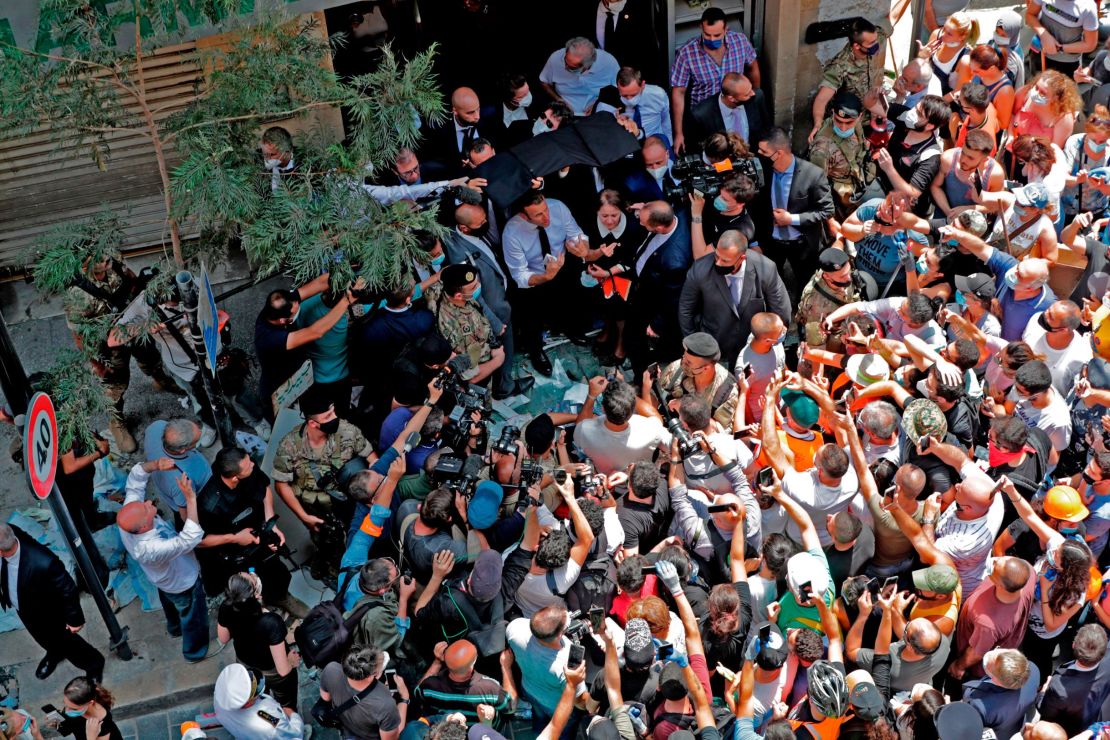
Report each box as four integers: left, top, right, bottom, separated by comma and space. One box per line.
27, 209, 123, 296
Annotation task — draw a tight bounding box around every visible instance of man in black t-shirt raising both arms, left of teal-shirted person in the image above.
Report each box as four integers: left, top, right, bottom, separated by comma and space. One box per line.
254, 273, 354, 422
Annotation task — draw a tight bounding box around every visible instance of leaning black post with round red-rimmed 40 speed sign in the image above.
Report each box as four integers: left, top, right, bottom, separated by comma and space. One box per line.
0, 323, 132, 660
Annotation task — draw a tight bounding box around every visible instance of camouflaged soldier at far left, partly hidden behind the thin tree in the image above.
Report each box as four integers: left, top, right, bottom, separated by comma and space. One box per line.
62, 255, 178, 454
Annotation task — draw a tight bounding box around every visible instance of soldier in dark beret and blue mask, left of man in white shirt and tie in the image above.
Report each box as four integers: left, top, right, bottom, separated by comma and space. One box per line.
425, 264, 505, 383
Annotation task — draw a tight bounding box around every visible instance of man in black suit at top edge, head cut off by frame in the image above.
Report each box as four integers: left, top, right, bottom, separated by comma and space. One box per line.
581, 0, 669, 82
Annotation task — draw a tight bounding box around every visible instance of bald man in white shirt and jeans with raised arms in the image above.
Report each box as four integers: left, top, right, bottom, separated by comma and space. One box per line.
115, 457, 209, 662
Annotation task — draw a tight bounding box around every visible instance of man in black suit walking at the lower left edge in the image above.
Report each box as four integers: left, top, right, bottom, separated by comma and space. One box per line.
0, 524, 104, 682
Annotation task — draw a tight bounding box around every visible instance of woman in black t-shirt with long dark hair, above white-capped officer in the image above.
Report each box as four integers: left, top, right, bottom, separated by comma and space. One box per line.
216, 572, 301, 711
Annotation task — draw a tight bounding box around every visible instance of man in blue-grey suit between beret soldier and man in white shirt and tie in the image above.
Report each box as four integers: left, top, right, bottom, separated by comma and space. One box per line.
443, 203, 535, 401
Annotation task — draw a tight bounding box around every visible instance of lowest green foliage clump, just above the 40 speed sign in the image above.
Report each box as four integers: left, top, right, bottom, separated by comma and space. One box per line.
37, 349, 115, 450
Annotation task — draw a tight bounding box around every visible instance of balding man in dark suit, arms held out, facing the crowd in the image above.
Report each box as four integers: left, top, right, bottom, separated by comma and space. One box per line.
678, 231, 790, 366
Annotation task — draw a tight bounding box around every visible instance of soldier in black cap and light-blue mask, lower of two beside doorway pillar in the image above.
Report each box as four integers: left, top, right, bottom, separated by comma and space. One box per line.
809, 91, 875, 221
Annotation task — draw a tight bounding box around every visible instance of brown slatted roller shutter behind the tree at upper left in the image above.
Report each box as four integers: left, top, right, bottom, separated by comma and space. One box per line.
0, 42, 202, 273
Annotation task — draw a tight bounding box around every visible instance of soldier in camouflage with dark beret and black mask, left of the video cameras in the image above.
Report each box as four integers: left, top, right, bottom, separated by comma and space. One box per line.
272, 389, 373, 580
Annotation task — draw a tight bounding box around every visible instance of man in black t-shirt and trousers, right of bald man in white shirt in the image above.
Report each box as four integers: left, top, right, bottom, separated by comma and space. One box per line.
196, 447, 293, 603
